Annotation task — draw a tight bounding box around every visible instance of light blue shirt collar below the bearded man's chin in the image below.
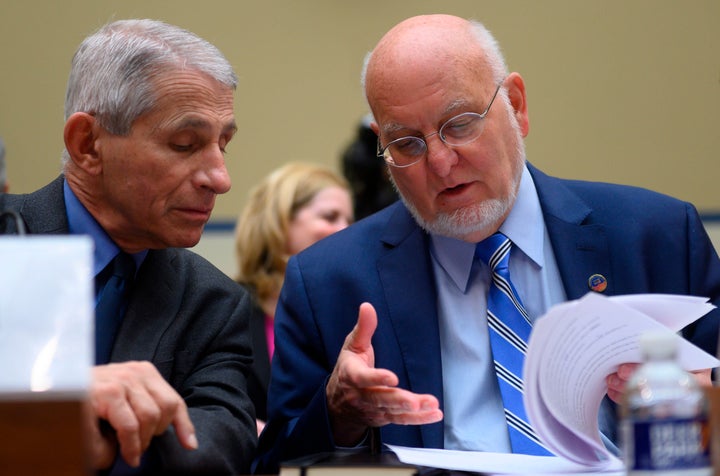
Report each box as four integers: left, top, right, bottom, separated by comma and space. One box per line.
430, 167, 545, 290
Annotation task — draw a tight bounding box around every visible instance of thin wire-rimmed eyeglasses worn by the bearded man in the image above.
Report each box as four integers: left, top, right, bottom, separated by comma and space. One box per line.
377, 82, 503, 168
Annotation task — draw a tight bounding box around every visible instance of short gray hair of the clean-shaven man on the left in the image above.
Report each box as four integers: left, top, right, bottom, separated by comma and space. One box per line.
63, 20, 238, 164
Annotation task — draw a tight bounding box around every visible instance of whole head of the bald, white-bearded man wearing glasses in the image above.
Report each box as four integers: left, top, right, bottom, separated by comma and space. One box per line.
363, 15, 529, 243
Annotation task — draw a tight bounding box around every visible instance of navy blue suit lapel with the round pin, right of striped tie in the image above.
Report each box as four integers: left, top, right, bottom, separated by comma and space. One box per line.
528, 164, 614, 299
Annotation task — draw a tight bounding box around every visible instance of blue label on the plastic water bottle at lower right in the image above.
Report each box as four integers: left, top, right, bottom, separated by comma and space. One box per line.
625, 418, 711, 470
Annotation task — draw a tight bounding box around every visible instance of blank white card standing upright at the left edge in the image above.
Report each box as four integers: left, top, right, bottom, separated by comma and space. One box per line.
0, 235, 94, 398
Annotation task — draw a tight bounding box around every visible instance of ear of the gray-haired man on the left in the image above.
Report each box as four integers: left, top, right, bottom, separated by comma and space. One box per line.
64, 112, 102, 175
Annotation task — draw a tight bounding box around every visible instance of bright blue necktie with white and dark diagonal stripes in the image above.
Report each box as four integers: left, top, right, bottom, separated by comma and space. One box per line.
475, 233, 552, 455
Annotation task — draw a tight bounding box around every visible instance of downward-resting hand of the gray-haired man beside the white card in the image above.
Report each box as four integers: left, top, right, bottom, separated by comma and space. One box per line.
88, 362, 197, 469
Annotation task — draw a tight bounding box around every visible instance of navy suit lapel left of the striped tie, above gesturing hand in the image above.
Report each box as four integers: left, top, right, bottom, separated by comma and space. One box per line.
378, 206, 443, 448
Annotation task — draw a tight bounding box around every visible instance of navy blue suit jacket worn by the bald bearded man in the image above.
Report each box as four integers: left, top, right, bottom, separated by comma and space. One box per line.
255, 165, 720, 472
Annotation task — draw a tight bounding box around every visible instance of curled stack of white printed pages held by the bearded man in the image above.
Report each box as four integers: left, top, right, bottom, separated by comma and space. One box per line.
524, 293, 720, 468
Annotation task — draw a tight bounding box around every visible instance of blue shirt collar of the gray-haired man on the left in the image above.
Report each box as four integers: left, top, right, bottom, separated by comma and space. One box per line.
63, 180, 147, 275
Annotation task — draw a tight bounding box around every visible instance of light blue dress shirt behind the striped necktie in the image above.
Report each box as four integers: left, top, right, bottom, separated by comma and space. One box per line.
430, 168, 566, 453
